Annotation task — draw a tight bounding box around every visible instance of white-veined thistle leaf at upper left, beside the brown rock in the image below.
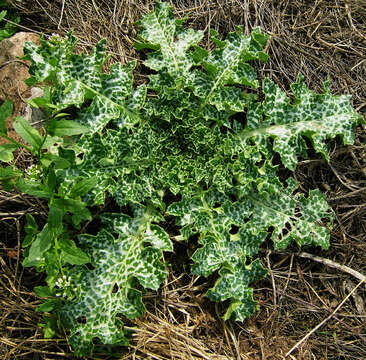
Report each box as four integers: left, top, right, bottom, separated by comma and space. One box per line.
24, 34, 144, 132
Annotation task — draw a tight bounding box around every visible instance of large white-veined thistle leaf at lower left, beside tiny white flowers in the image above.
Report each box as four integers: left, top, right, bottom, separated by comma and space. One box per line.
61, 214, 166, 355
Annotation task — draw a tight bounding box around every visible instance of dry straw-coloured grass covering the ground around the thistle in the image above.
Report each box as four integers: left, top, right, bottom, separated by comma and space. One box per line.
0, 0, 366, 360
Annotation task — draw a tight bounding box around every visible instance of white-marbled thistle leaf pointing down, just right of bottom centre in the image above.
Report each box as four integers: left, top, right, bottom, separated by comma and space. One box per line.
167, 189, 267, 321
